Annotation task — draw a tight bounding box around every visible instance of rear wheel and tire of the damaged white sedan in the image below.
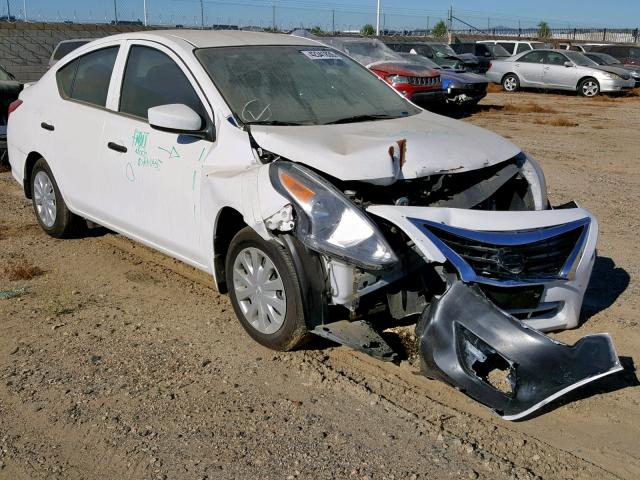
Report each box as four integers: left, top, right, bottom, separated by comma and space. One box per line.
31, 158, 80, 238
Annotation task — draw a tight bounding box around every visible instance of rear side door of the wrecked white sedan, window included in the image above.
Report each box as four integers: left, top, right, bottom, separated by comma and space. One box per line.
47, 43, 120, 216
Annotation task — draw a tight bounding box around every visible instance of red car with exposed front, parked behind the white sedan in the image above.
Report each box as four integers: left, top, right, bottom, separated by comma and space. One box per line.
319, 37, 446, 104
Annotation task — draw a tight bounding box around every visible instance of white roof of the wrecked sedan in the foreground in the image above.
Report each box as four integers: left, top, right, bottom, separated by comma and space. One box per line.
110, 29, 318, 48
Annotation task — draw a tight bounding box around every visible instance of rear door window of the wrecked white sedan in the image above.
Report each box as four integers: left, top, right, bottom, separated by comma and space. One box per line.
56, 47, 119, 107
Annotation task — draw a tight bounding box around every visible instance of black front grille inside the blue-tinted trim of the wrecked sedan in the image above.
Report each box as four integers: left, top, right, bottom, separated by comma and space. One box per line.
429, 226, 584, 279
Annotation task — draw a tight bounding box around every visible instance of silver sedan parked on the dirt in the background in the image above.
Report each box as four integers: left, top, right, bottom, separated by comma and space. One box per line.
486, 50, 635, 97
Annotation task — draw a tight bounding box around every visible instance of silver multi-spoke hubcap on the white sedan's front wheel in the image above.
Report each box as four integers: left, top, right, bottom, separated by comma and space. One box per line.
233, 247, 287, 334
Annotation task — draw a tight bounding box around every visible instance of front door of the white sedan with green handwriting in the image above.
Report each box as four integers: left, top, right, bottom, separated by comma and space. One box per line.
102, 41, 213, 265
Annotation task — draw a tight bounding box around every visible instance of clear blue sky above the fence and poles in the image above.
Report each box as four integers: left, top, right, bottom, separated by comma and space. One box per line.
8, 0, 640, 29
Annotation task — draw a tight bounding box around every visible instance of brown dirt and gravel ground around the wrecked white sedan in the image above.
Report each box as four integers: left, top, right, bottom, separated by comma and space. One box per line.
0, 93, 640, 480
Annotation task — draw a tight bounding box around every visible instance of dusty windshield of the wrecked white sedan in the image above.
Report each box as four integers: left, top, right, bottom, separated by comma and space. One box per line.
195, 45, 420, 125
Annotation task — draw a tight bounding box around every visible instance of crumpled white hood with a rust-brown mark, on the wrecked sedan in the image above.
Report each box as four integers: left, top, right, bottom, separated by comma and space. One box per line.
251, 111, 520, 185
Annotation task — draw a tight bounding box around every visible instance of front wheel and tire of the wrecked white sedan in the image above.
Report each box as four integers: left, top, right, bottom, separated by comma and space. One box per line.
225, 227, 309, 351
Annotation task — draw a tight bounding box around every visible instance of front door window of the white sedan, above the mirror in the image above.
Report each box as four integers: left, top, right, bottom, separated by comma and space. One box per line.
120, 46, 206, 119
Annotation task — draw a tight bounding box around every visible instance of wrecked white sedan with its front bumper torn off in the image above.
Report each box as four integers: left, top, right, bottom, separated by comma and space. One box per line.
8, 30, 622, 419
